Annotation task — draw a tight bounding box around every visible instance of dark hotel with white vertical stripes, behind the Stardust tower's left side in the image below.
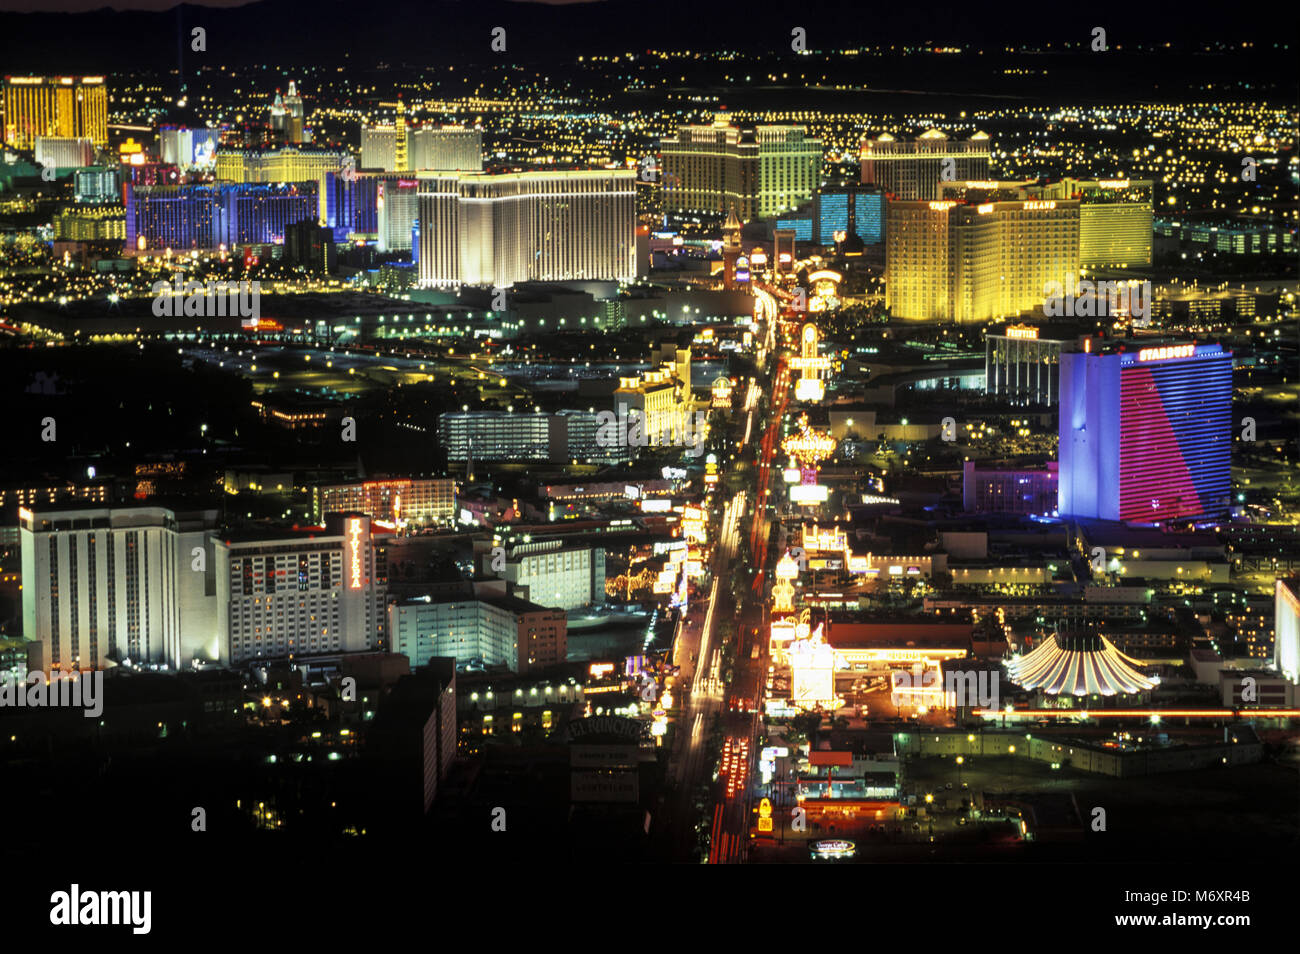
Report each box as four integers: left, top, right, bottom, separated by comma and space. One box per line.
984, 325, 1080, 407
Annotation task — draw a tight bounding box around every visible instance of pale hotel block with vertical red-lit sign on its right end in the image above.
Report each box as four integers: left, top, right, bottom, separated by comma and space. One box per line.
215, 513, 387, 665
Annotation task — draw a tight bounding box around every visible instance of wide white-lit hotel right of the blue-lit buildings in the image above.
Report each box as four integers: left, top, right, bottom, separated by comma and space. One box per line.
419, 169, 637, 289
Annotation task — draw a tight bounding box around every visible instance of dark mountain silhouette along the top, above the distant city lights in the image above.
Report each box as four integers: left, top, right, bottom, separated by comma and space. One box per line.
0, 0, 1297, 73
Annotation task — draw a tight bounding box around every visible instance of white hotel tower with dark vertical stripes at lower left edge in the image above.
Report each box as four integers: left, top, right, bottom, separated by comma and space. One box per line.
18, 506, 217, 669
